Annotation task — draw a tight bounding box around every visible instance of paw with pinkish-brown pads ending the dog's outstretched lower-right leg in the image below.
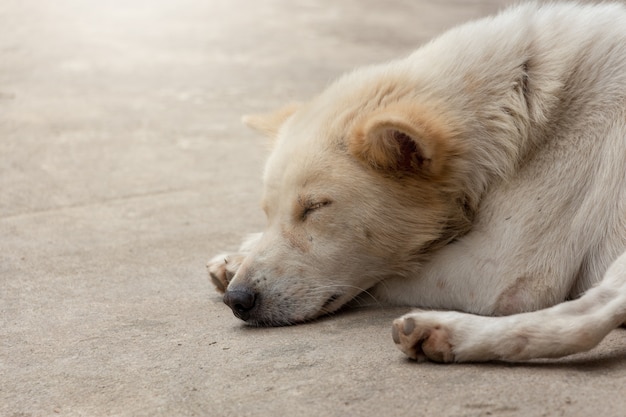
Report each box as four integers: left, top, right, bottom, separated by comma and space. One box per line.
392, 312, 454, 362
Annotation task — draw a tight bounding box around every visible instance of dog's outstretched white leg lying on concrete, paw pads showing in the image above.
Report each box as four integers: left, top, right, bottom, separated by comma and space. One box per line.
393, 252, 626, 362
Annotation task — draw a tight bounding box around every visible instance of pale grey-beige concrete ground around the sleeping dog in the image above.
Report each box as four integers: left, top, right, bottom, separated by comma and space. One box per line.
0, 0, 626, 417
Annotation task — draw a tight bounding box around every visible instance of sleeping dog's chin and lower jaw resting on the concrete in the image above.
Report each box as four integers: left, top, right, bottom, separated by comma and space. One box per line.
245, 293, 353, 327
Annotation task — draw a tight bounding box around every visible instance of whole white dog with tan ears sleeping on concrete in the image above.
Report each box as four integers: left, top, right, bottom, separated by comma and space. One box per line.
209, 4, 626, 361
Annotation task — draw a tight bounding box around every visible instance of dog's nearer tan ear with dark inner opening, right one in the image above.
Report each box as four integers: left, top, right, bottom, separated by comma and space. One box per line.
349, 103, 454, 177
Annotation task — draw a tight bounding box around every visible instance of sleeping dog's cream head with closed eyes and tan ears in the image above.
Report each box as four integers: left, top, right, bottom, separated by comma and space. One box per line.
225, 69, 502, 325
